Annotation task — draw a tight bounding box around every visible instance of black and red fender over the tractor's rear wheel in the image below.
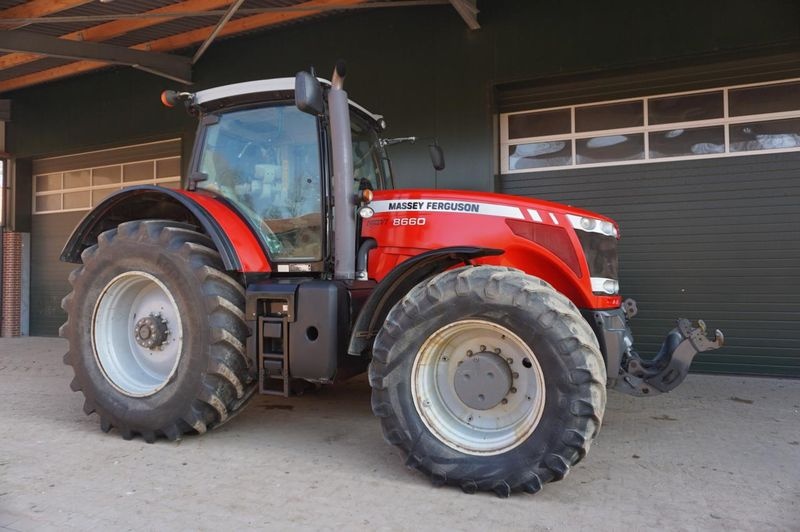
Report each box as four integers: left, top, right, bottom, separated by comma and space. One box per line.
61, 185, 271, 272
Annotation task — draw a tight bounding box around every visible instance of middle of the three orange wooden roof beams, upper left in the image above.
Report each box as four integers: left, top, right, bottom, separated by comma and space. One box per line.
0, 0, 231, 70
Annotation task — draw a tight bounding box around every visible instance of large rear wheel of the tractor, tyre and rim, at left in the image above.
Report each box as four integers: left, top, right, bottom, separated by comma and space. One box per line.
60, 220, 255, 443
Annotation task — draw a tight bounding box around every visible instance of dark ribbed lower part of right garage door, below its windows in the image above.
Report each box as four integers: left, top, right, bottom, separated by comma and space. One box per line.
500, 153, 800, 377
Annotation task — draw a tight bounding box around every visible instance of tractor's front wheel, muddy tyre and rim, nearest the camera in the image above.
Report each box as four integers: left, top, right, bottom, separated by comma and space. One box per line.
369, 266, 606, 497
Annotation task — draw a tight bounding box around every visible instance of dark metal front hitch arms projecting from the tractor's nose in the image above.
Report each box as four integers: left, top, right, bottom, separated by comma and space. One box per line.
613, 318, 725, 396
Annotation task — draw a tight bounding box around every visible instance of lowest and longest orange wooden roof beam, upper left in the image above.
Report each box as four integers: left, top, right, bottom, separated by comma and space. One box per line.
0, 0, 367, 92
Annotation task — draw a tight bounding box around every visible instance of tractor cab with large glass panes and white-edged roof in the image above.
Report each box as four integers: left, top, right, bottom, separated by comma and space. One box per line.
183, 78, 392, 271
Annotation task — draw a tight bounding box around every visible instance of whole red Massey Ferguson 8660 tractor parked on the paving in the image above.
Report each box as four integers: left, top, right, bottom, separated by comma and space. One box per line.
61, 65, 722, 496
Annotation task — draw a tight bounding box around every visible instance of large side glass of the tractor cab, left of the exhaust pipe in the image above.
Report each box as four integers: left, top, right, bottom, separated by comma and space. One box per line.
197, 105, 322, 261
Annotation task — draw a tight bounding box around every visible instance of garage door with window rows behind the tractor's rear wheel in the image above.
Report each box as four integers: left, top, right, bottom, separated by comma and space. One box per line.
30, 139, 181, 336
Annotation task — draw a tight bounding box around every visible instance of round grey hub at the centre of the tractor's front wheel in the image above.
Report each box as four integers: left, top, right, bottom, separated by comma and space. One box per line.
453, 351, 512, 410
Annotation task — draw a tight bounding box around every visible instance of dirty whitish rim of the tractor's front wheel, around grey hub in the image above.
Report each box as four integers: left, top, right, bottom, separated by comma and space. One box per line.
411, 319, 545, 455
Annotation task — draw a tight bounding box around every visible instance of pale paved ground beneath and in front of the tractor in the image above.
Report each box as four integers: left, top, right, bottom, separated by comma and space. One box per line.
0, 338, 800, 531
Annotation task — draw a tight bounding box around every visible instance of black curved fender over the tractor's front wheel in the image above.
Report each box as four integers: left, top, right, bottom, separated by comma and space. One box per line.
347, 246, 503, 356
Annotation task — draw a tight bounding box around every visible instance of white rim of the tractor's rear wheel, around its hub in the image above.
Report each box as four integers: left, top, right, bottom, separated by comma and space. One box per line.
92, 271, 183, 397
